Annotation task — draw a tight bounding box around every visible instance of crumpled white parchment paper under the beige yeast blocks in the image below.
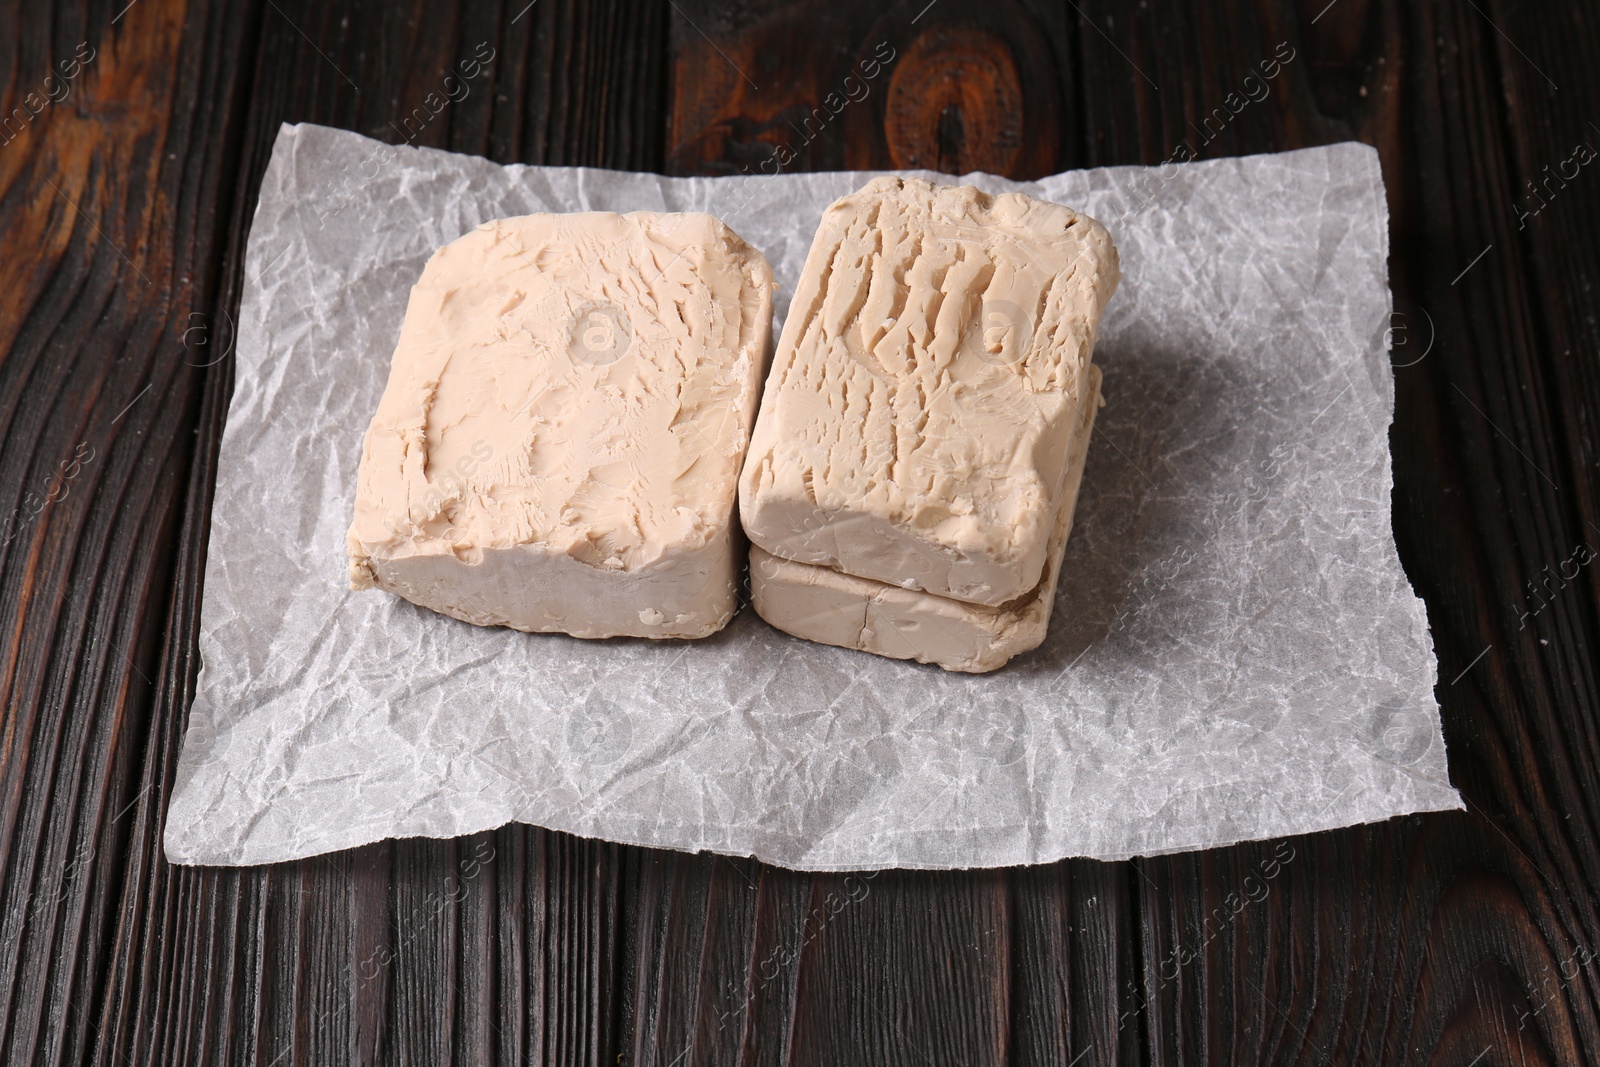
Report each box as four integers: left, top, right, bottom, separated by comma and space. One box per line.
165, 125, 1461, 870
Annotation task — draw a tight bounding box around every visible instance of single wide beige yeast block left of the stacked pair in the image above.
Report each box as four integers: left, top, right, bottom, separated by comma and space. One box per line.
349, 211, 773, 638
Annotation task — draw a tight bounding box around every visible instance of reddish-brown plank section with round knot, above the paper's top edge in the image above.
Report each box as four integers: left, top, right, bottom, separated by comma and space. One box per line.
669, 0, 1072, 178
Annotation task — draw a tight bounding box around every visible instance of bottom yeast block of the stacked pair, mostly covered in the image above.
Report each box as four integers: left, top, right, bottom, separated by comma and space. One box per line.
750, 366, 1104, 673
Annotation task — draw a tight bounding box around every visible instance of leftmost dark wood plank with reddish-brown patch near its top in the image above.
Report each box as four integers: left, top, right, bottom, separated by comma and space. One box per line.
0, 5, 246, 1062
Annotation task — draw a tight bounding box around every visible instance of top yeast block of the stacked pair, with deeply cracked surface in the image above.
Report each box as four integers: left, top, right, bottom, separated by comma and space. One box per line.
739, 178, 1118, 606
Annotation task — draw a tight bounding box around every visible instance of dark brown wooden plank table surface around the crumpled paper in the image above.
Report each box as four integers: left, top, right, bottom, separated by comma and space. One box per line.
0, 0, 1600, 1067
